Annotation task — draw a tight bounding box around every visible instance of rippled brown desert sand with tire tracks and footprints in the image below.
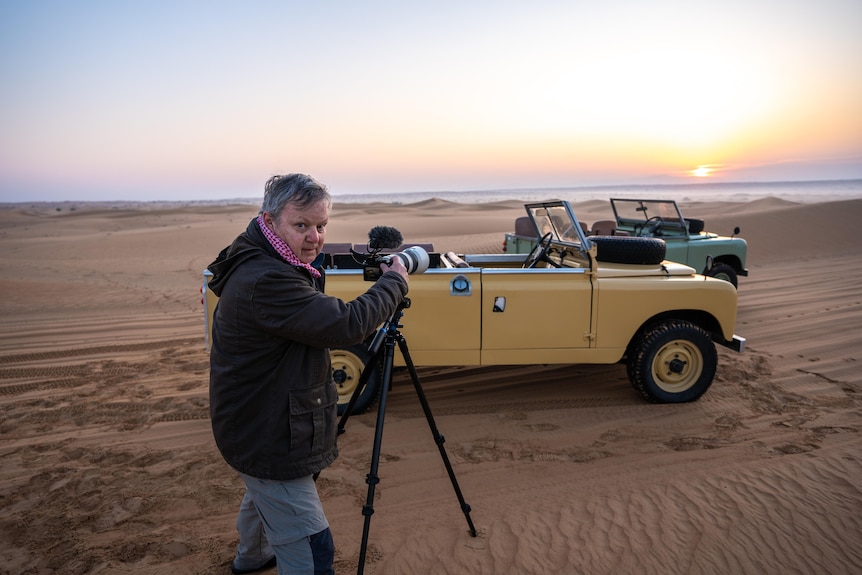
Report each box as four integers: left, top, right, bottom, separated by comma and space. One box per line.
0, 197, 862, 575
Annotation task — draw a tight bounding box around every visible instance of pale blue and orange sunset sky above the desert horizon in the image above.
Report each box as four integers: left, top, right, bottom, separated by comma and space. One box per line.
0, 0, 862, 202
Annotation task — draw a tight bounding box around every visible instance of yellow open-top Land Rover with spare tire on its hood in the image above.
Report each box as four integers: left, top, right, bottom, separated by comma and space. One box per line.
203, 201, 745, 412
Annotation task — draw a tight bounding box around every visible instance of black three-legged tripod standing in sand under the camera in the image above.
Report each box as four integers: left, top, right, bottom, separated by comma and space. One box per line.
338, 298, 476, 575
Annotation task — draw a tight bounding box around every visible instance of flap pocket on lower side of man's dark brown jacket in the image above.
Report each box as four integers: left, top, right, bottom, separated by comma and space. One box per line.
290, 382, 338, 459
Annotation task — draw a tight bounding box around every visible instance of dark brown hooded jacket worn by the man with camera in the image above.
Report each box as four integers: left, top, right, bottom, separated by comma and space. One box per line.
209, 219, 407, 480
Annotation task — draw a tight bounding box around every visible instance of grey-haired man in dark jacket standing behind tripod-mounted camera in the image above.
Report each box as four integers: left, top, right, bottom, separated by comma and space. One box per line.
209, 174, 408, 575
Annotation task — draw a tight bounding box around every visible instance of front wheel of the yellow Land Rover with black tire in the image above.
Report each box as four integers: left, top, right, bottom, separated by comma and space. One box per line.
626, 320, 718, 403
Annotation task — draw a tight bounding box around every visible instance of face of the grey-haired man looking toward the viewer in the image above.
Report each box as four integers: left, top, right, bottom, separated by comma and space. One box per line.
263, 200, 329, 264
